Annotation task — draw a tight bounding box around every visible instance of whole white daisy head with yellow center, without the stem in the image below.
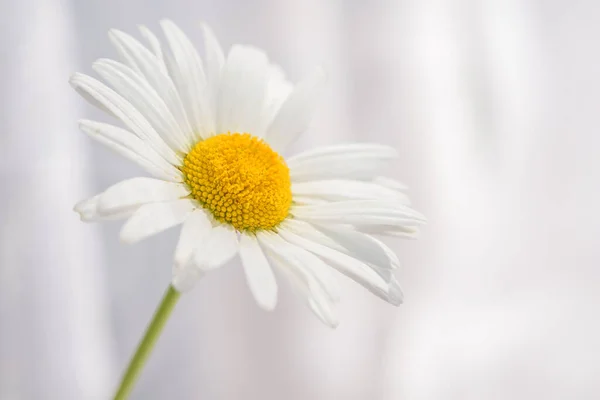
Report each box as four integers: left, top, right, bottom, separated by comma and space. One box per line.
70, 21, 425, 326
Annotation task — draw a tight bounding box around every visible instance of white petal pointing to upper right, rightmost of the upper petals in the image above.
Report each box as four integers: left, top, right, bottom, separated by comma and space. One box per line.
265, 69, 326, 152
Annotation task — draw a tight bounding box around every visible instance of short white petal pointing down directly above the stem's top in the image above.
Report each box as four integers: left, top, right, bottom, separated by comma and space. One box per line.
175, 208, 212, 268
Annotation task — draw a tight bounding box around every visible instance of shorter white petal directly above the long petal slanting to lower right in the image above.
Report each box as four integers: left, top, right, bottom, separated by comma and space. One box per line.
317, 225, 399, 268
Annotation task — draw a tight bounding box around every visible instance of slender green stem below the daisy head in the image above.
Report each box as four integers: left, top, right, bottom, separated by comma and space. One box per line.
114, 285, 181, 400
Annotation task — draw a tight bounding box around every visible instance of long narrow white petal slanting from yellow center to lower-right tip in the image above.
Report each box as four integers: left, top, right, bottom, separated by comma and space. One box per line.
279, 228, 390, 301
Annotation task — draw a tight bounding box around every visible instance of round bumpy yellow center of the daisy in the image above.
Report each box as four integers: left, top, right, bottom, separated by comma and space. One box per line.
181, 133, 292, 232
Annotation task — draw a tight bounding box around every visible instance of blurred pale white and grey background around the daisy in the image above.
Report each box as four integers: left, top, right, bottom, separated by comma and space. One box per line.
0, 0, 600, 400
